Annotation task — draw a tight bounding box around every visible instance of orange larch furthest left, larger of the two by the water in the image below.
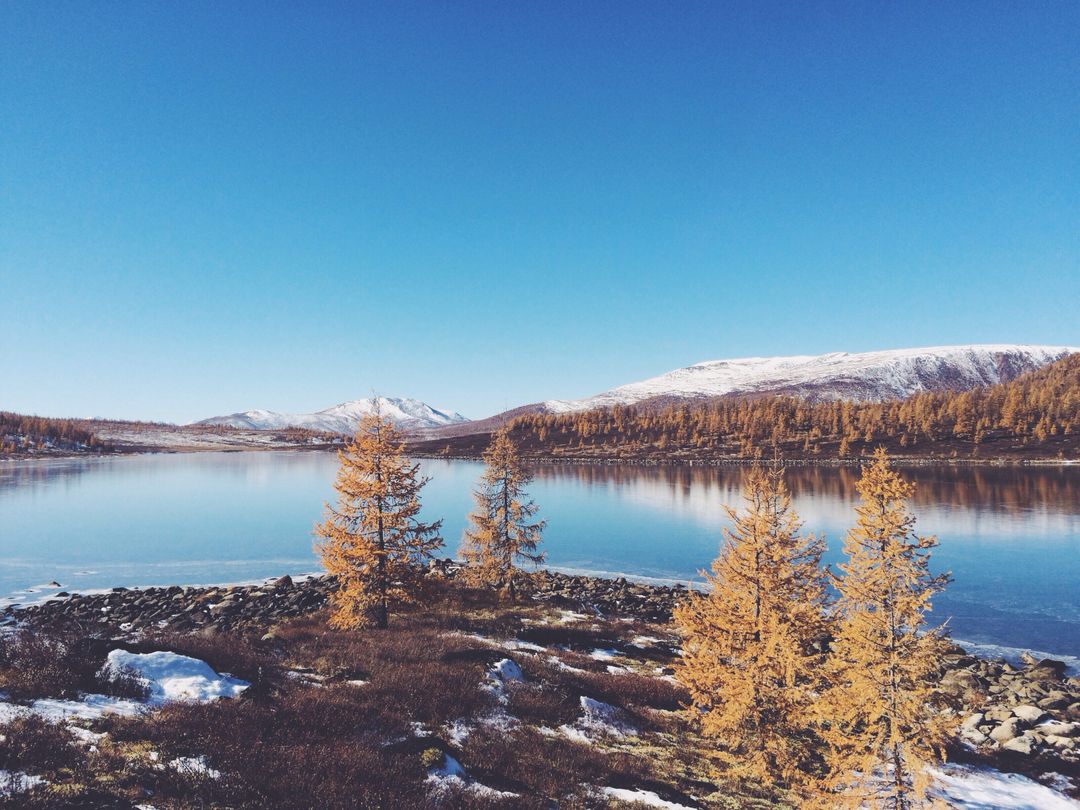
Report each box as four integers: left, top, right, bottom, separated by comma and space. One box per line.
315, 408, 443, 629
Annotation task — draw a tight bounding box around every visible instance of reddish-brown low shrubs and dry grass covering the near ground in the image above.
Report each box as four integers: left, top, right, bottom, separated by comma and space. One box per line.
3, 592, 756, 809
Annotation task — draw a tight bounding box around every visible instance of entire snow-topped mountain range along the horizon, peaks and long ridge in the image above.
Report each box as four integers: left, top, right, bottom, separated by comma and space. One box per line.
197, 345, 1080, 437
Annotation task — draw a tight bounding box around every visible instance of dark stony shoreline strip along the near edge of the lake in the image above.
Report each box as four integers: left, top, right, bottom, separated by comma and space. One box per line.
3, 559, 1080, 775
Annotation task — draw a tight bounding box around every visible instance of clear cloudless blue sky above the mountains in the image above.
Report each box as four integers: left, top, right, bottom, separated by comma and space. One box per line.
0, 0, 1080, 421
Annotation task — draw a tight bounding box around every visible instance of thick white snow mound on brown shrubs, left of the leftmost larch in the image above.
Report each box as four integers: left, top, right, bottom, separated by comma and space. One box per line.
105, 650, 251, 705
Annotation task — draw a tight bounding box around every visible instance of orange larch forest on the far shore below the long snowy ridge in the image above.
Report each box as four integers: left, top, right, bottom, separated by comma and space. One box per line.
417, 354, 1080, 460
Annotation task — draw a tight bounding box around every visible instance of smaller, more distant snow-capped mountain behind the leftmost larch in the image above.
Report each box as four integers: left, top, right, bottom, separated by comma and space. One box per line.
194, 396, 469, 433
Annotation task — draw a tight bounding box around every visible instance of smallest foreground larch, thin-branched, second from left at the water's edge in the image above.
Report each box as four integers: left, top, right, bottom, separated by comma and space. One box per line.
461, 431, 545, 599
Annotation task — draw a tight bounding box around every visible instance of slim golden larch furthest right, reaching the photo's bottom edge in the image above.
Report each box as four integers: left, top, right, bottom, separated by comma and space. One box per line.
820, 448, 951, 810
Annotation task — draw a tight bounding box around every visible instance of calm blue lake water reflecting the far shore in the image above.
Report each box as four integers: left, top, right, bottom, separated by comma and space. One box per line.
0, 453, 1080, 657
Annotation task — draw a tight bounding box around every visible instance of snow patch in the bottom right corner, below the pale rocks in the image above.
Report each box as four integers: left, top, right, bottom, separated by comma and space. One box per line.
931, 765, 1080, 810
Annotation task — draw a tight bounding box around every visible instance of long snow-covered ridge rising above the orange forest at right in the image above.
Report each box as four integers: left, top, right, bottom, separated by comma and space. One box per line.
542, 345, 1080, 413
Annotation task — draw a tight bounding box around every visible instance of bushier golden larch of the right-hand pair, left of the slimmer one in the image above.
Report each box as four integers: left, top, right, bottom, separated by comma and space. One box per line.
675, 467, 827, 795
